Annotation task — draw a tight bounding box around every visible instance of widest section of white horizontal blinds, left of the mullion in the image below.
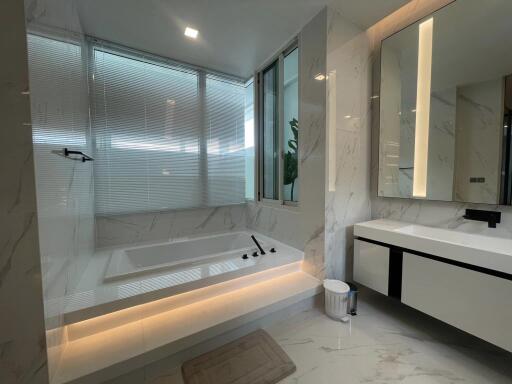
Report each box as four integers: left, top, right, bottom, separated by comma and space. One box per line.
93, 49, 201, 214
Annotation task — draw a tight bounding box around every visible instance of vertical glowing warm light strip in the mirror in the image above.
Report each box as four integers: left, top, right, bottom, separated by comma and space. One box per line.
412, 18, 434, 197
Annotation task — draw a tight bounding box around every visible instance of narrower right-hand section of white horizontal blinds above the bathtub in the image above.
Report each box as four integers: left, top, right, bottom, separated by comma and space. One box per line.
205, 75, 246, 206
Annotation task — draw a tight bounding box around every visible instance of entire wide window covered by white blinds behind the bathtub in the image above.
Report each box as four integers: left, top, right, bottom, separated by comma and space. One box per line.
91, 44, 254, 215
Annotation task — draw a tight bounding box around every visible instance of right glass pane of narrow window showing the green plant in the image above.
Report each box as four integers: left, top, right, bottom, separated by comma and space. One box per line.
282, 48, 299, 201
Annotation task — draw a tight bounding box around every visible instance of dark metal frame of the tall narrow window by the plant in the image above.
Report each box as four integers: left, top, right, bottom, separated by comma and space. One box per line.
254, 37, 301, 209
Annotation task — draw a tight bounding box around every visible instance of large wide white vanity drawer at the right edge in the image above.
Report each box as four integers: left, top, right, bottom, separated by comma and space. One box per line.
402, 252, 512, 351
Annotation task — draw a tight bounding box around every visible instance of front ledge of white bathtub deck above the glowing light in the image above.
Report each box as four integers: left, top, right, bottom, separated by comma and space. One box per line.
45, 235, 304, 324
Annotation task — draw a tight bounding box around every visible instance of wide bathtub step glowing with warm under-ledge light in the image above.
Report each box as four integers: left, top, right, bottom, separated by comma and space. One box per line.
54, 271, 322, 384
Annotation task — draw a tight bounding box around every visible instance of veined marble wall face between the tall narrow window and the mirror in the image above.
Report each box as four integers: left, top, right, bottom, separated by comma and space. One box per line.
325, 7, 371, 280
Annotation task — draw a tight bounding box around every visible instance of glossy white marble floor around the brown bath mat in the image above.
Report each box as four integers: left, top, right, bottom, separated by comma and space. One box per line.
112, 290, 512, 384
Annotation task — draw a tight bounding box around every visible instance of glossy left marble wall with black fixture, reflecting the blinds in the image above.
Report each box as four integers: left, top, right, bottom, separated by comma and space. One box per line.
25, 0, 94, 377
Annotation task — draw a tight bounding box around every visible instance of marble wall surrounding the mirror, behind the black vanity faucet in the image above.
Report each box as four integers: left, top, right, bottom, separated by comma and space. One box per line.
367, 0, 512, 238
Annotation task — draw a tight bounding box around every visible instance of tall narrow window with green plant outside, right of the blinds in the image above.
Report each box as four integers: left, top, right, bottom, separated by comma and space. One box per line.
259, 45, 299, 204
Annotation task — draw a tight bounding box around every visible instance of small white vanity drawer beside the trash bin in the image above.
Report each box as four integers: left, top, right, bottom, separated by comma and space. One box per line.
354, 239, 390, 295
